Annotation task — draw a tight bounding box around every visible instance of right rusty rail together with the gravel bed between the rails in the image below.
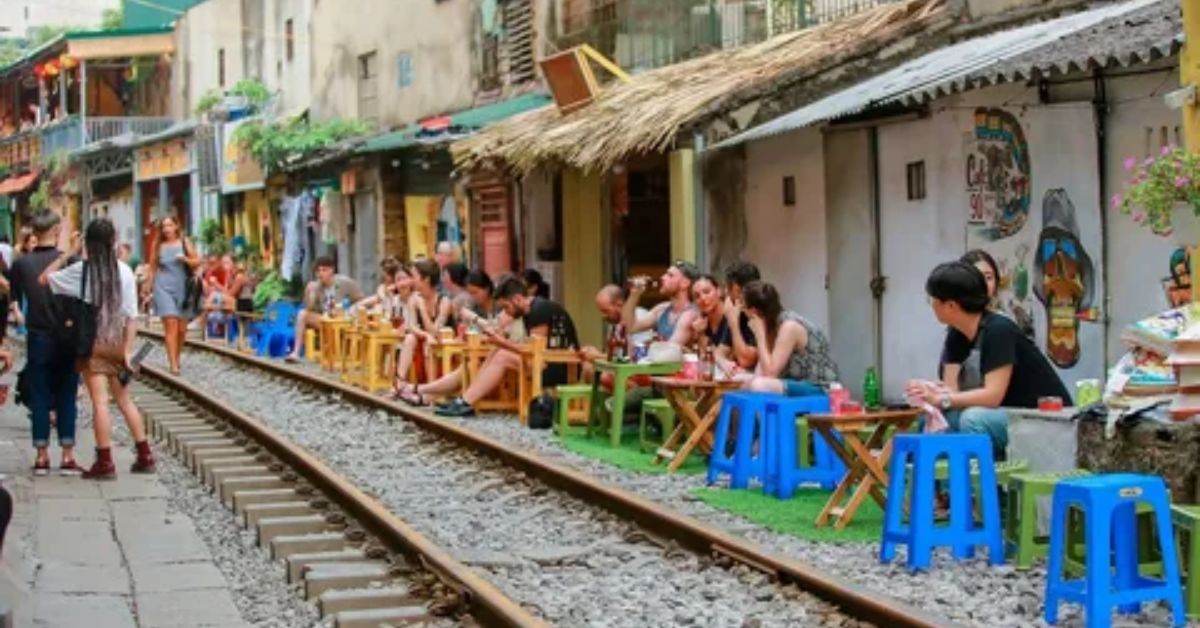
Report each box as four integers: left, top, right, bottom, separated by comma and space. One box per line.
138, 333, 946, 627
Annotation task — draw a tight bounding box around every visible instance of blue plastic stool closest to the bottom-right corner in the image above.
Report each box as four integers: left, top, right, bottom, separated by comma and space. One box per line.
1045, 473, 1186, 628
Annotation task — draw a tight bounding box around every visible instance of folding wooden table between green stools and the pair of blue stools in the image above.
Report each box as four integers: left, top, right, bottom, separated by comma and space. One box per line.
652, 377, 742, 472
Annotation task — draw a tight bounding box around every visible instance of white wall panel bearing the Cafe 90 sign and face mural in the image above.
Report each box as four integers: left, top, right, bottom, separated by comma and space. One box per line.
960, 107, 1103, 384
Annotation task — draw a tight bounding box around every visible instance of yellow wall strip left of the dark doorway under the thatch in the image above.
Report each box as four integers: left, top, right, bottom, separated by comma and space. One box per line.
563, 169, 607, 347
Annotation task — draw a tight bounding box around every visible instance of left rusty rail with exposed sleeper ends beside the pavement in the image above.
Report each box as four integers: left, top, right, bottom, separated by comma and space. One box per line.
134, 366, 547, 628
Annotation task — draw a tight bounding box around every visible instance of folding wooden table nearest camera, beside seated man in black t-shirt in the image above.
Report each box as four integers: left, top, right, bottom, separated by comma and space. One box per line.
808, 408, 920, 530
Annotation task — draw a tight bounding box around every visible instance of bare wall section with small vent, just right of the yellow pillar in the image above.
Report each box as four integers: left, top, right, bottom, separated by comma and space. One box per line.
742, 128, 829, 329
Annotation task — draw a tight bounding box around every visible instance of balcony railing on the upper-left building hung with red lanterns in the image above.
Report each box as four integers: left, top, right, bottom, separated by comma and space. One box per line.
0, 116, 174, 168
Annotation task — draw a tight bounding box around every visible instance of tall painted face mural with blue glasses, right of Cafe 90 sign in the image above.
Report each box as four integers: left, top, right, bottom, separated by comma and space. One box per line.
1033, 189, 1096, 369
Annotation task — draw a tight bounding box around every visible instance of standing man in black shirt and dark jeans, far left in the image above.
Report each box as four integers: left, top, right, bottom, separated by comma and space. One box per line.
11, 210, 79, 476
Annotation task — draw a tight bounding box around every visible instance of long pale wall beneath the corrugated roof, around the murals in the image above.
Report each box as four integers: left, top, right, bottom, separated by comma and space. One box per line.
729, 67, 1180, 396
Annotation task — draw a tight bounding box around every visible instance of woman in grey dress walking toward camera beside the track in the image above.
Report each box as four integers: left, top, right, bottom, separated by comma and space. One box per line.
145, 216, 200, 375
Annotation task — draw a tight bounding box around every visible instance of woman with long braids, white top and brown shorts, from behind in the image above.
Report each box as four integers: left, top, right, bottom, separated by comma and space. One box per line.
38, 219, 155, 480
